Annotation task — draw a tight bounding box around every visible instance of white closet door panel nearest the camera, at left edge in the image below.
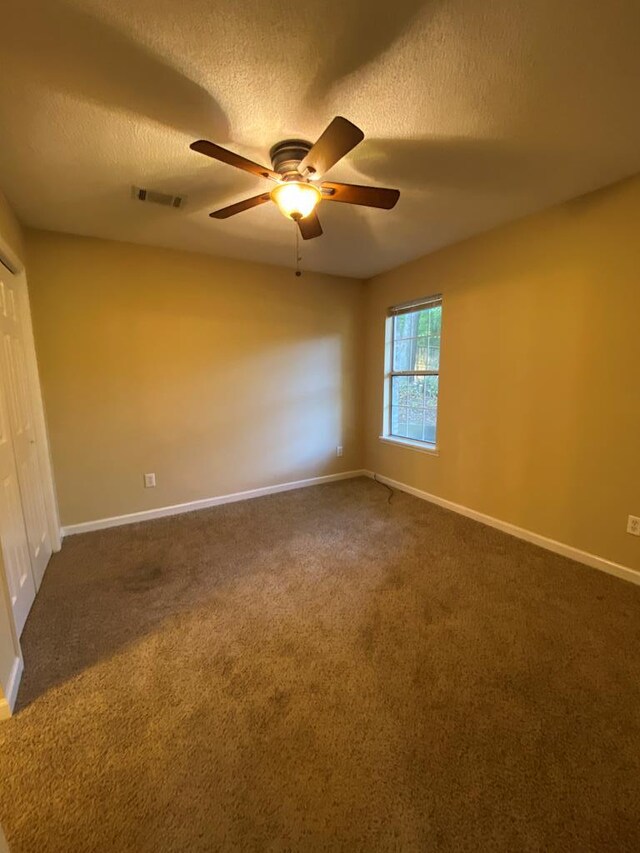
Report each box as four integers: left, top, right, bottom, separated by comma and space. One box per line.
0, 280, 36, 635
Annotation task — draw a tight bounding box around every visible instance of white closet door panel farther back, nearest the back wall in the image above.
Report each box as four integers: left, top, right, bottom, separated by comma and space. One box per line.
0, 274, 52, 589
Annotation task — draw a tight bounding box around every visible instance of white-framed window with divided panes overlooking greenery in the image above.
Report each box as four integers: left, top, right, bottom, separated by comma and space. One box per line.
383, 296, 442, 449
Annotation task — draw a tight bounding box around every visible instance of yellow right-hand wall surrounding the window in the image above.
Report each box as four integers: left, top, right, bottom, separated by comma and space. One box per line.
365, 178, 640, 569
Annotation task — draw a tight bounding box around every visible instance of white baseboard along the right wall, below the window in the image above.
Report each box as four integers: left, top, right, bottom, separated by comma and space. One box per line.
364, 471, 640, 584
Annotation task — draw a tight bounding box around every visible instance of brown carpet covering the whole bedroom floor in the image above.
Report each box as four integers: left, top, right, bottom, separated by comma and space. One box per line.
0, 479, 640, 853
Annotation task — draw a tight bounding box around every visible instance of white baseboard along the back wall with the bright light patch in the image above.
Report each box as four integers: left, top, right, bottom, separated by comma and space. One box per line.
61, 470, 368, 536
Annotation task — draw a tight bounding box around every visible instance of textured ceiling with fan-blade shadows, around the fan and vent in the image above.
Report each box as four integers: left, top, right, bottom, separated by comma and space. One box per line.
0, 0, 640, 277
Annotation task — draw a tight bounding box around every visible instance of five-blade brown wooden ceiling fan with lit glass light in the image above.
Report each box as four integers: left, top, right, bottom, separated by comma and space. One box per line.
190, 116, 400, 240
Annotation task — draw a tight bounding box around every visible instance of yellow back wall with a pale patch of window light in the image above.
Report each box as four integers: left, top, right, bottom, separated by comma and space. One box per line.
27, 231, 363, 525
